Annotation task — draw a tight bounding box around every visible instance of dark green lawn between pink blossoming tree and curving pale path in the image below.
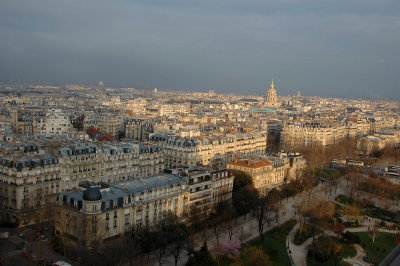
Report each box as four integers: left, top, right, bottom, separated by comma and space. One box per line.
219, 220, 296, 266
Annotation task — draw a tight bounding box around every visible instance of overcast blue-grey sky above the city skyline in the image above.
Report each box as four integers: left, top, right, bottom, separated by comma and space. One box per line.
0, 0, 400, 100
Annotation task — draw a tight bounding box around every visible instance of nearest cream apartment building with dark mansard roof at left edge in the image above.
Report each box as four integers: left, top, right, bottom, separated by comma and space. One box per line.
0, 154, 63, 224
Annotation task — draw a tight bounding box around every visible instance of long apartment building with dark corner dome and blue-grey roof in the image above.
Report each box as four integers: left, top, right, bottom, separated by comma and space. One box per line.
56, 174, 189, 245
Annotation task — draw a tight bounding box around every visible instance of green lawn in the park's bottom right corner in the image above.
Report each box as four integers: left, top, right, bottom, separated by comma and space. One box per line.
355, 232, 397, 265
